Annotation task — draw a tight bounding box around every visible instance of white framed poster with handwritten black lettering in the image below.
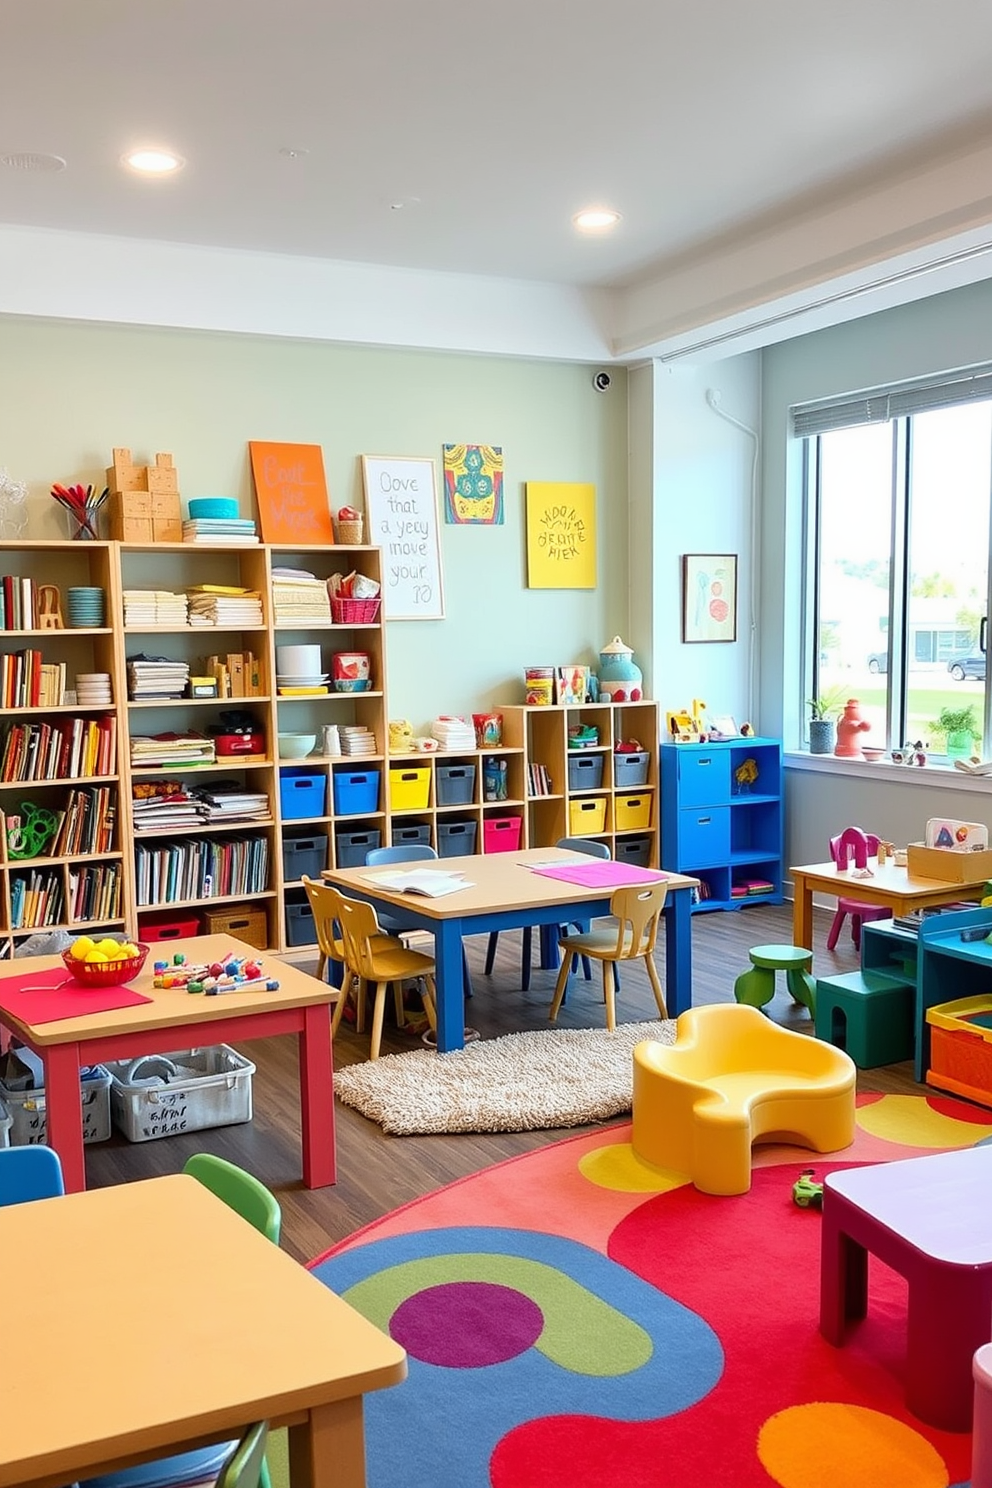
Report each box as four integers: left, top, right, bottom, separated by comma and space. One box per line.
361, 455, 445, 620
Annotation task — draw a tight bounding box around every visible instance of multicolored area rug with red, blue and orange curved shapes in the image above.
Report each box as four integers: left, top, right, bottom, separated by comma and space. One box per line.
312, 1095, 992, 1488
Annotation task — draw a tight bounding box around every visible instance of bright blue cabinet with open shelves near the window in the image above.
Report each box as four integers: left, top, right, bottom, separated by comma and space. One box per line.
660, 738, 784, 909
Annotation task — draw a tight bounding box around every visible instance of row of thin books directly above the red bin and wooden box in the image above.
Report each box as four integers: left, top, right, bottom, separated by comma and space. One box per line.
134, 836, 269, 909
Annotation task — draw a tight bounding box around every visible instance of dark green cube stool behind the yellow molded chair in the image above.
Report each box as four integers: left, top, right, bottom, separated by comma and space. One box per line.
815, 972, 916, 1070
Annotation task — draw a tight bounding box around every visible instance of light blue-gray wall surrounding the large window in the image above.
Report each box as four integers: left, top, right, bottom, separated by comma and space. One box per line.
760, 281, 992, 863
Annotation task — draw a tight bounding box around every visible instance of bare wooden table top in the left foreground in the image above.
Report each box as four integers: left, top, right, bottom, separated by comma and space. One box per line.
0, 1174, 406, 1488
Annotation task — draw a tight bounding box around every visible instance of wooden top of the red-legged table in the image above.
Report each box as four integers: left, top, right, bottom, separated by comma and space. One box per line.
0, 934, 338, 1048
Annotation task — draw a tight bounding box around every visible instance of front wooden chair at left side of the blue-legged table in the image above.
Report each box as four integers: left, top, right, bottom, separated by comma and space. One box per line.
330, 890, 437, 1059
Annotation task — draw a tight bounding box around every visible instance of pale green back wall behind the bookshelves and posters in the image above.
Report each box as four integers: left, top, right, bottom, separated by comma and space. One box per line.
0, 317, 629, 731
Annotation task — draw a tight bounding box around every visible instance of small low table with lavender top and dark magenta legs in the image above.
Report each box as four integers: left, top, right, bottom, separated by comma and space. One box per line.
819, 1147, 992, 1431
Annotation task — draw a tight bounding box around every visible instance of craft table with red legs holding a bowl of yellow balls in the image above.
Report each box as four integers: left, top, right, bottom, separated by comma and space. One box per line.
0, 934, 338, 1193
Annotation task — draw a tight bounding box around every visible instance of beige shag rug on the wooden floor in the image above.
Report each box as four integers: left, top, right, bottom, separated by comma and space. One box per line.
335, 1019, 675, 1137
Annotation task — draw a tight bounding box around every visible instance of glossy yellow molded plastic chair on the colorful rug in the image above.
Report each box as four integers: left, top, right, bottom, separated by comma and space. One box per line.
632, 1003, 855, 1193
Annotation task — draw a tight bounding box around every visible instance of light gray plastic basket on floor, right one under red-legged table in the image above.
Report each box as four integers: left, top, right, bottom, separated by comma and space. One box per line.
107, 1043, 254, 1141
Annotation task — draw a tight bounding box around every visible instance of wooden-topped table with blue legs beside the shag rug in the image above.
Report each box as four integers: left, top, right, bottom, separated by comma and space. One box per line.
323, 847, 699, 1054
